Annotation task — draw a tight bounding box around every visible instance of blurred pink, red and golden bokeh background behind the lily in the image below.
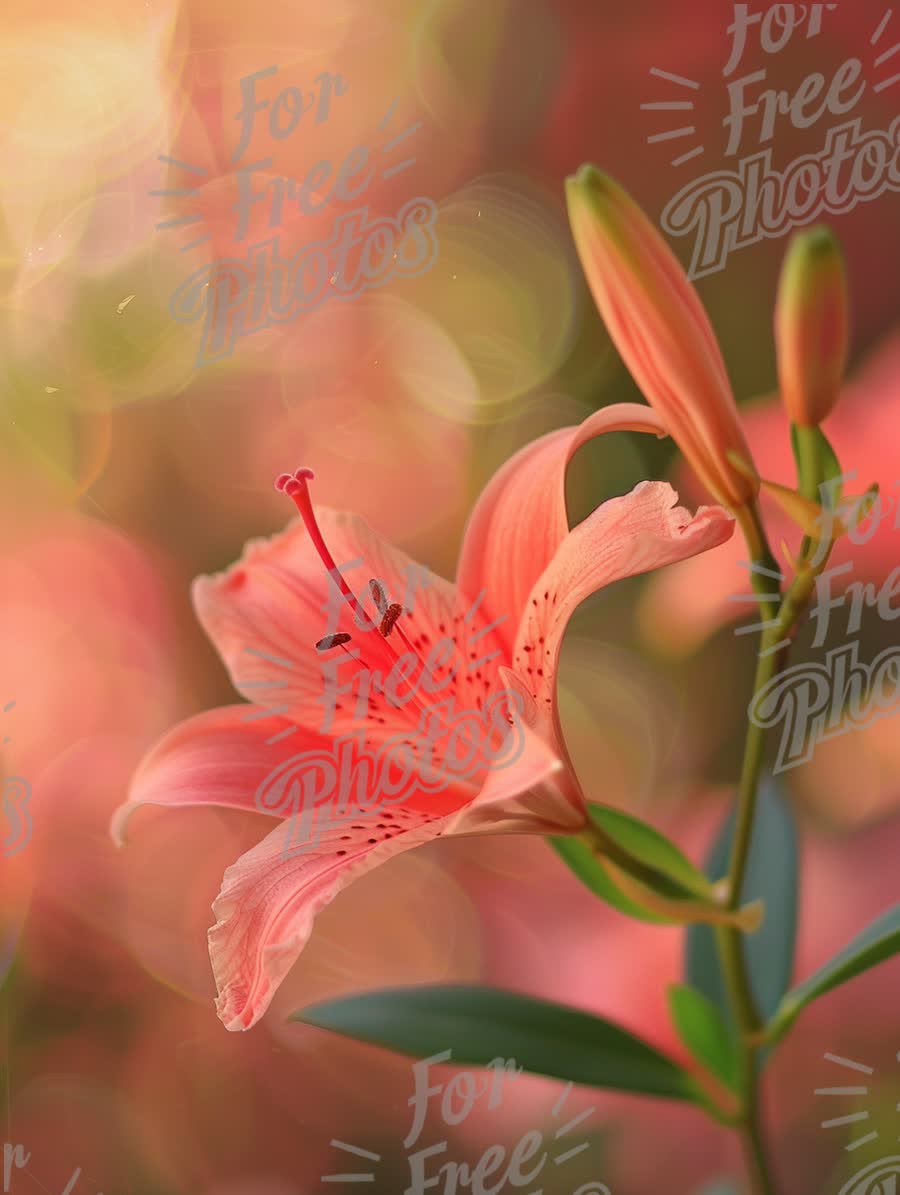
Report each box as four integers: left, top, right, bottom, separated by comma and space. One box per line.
0, 0, 900, 1195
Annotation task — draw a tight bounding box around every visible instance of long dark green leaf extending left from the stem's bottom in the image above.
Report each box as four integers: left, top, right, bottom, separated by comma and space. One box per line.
290, 985, 702, 1102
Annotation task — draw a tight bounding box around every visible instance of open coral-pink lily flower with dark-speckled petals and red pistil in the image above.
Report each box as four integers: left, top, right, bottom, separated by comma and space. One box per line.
112, 404, 734, 1030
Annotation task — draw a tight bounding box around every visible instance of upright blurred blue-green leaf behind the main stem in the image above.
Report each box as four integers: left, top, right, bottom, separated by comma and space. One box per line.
685, 780, 797, 1024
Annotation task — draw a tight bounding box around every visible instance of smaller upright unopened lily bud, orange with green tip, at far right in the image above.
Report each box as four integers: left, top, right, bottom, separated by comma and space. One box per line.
775, 226, 850, 428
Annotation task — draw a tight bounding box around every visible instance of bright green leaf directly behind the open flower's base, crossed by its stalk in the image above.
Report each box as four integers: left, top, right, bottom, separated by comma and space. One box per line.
550, 804, 710, 924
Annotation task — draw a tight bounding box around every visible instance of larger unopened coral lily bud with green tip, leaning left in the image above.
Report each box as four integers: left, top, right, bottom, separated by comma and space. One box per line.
565, 166, 759, 509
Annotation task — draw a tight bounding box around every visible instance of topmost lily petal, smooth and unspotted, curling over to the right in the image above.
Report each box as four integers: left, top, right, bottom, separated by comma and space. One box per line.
457, 403, 666, 650
